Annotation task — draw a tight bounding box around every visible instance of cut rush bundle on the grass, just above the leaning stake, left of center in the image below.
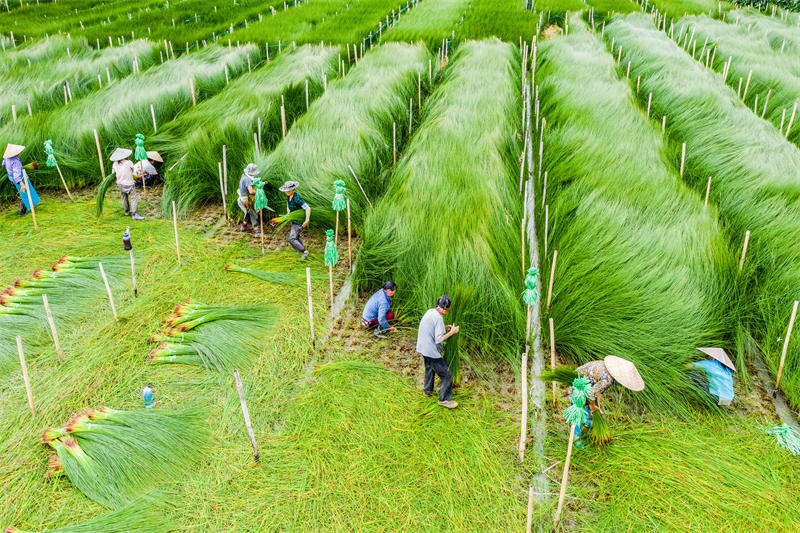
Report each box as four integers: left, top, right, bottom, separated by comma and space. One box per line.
149, 300, 277, 372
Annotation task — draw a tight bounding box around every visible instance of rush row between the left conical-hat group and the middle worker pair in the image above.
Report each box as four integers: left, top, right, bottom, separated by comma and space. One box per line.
158, 46, 338, 215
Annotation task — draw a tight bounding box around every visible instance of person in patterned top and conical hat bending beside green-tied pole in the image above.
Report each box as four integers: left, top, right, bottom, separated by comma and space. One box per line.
570, 355, 644, 442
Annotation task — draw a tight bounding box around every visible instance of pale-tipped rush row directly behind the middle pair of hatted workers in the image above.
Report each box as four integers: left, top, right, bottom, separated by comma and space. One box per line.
248, 43, 430, 232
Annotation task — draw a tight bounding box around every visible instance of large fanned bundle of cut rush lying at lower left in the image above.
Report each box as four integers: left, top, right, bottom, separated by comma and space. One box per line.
42, 407, 207, 509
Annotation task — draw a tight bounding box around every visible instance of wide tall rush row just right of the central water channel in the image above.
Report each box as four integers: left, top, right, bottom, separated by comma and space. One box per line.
536, 17, 734, 408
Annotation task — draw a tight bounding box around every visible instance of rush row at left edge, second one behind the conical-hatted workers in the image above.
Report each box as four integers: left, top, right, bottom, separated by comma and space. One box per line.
0, 40, 158, 123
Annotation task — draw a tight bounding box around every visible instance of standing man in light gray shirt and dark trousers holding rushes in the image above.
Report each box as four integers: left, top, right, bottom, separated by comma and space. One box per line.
417, 296, 459, 409
